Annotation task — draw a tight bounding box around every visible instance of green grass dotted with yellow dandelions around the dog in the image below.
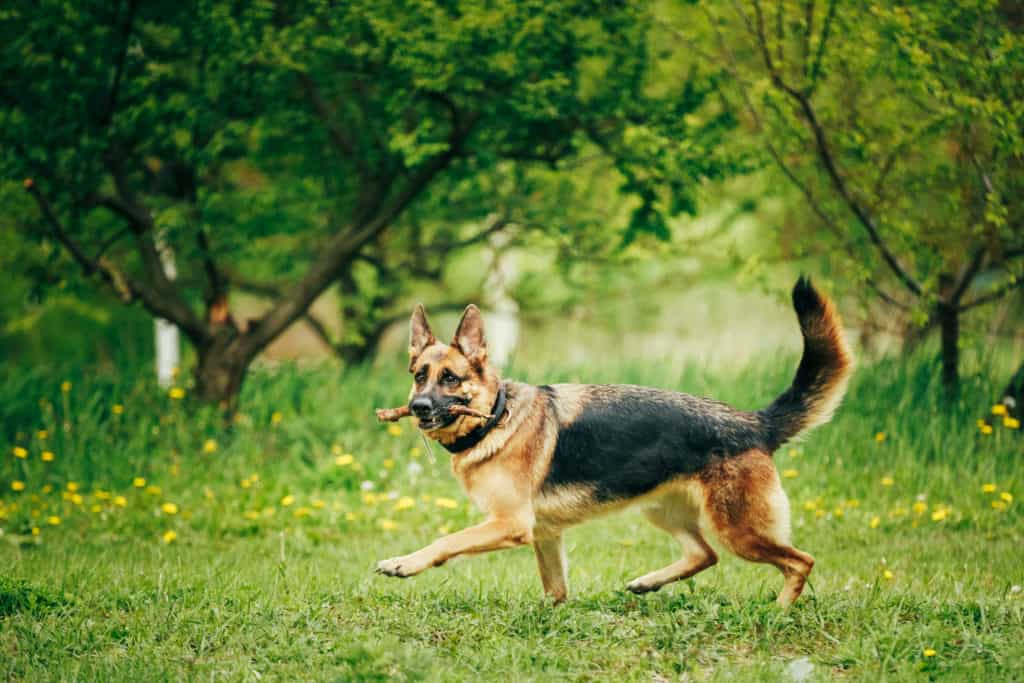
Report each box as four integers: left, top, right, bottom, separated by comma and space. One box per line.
0, 350, 1024, 681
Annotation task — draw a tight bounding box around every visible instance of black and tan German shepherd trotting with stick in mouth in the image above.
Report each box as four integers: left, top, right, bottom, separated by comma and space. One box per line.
377, 278, 853, 606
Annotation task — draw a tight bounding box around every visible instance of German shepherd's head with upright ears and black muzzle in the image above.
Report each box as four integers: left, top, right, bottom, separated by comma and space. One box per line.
409, 304, 501, 443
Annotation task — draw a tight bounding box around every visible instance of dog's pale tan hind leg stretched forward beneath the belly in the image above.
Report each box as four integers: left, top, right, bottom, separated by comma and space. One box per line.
626, 498, 718, 593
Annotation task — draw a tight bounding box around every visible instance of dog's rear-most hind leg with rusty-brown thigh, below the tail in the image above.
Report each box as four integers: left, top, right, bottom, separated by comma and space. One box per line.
708, 454, 814, 607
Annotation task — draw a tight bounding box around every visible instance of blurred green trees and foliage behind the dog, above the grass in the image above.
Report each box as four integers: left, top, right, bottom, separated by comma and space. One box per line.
0, 0, 1024, 411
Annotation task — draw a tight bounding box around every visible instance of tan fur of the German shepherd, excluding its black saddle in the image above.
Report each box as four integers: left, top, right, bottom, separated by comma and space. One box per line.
378, 288, 849, 606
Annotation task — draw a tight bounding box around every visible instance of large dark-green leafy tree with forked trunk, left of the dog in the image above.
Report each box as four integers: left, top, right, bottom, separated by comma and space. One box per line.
6, 0, 724, 409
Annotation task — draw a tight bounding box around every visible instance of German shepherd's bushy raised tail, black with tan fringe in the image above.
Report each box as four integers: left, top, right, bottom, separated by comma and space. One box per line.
759, 276, 853, 451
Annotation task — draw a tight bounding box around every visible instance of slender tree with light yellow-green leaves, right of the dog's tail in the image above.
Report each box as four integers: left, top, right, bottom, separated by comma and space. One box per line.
663, 0, 1024, 389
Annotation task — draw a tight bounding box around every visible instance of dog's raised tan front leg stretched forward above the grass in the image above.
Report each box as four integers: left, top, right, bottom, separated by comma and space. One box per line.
377, 517, 534, 579
